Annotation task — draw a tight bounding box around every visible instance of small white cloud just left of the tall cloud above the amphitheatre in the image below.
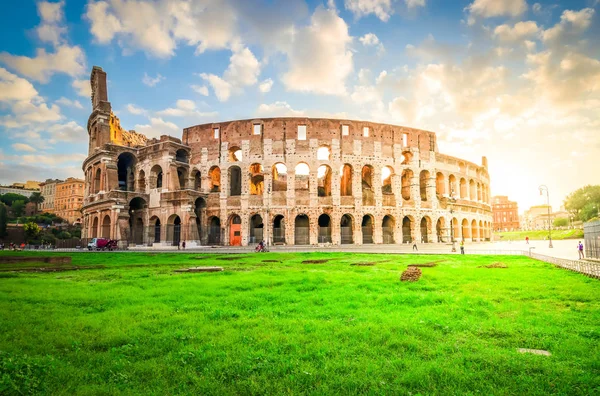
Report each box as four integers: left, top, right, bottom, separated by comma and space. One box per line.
200, 48, 260, 102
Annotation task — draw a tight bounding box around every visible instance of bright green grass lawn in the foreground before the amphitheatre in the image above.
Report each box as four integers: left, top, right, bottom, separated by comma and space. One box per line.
0, 253, 600, 395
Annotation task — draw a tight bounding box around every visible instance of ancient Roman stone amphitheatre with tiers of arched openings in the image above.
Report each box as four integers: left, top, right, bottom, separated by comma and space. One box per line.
82, 66, 492, 247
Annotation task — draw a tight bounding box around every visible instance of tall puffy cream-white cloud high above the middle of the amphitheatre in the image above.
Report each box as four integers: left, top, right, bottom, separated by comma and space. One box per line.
282, 6, 353, 95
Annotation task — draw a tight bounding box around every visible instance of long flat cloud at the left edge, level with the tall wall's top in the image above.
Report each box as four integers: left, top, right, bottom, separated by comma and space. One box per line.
0, 45, 85, 83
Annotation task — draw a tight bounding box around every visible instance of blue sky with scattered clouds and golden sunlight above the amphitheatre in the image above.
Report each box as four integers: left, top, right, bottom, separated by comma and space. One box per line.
0, 0, 600, 212
